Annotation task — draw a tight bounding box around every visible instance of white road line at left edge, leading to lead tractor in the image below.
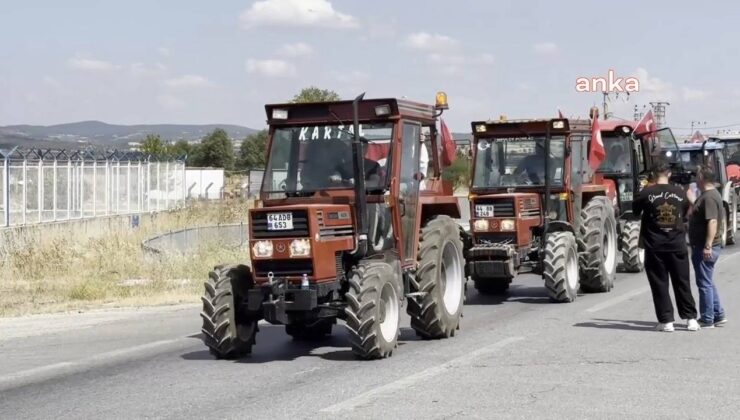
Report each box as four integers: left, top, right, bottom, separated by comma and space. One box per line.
0, 337, 192, 391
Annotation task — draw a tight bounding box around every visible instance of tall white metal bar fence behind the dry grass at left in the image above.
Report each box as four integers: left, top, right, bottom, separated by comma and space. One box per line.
0, 148, 185, 226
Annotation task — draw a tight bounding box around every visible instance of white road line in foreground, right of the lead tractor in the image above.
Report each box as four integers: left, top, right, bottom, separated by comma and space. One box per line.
320, 337, 524, 413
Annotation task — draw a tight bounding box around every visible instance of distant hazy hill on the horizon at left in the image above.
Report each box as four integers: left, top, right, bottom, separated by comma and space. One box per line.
0, 121, 257, 148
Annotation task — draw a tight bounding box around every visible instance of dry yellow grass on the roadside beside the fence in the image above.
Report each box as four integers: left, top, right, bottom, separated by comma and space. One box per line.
0, 201, 248, 316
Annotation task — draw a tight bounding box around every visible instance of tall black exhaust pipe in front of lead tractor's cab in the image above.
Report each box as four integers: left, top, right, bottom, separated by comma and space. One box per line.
352, 92, 368, 256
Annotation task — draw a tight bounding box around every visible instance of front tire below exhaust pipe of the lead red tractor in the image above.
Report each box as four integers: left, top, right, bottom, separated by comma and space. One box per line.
344, 260, 401, 359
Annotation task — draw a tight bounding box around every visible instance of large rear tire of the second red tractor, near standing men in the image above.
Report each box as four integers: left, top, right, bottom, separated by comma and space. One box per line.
578, 196, 617, 293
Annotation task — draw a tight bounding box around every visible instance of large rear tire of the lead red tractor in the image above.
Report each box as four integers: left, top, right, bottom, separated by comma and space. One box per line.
407, 215, 465, 339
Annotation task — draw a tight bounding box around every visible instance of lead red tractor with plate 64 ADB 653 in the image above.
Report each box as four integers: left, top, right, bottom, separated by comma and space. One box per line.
201, 93, 465, 359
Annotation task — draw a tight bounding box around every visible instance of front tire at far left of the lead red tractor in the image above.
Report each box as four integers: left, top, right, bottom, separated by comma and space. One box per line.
200, 265, 258, 359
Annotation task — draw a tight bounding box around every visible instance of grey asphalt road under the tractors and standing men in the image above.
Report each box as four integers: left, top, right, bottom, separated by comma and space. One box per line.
0, 247, 740, 419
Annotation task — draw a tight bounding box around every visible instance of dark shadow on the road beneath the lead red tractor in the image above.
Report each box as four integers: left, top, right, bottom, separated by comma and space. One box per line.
180, 324, 420, 363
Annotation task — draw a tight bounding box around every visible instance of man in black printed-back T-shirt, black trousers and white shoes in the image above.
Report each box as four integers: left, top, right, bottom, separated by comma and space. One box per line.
632, 162, 699, 332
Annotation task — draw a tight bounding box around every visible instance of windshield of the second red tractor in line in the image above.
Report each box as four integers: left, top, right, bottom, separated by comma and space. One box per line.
473, 136, 565, 188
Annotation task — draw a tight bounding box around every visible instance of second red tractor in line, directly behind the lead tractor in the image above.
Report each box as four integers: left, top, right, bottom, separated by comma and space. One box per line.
466, 118, 617, 302
